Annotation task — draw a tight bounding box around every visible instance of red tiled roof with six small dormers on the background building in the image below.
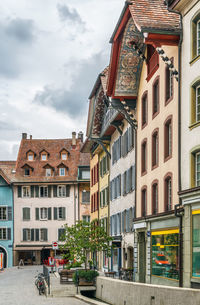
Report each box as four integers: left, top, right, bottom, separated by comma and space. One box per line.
15, 139, 89, 182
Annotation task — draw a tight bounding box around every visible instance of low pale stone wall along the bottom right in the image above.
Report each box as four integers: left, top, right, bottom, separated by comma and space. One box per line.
96, 277, 200, 305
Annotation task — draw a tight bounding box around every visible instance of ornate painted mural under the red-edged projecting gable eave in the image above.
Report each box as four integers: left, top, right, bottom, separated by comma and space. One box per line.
115, 18, 144, 96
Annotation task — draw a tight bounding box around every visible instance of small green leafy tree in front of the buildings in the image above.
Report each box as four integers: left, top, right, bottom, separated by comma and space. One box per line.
60, 220, 112, 268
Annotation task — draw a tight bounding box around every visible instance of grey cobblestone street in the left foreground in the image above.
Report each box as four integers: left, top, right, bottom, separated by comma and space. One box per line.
0, 266, 90, 305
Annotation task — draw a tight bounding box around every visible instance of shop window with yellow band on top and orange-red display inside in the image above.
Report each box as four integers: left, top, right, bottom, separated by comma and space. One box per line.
151, 229, 179, 281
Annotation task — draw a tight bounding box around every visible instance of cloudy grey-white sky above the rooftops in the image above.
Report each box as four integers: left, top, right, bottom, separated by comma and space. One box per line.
0, 0, 124, 160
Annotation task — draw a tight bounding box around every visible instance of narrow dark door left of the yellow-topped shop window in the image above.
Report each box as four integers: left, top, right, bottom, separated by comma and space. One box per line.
138, 232, 146, 283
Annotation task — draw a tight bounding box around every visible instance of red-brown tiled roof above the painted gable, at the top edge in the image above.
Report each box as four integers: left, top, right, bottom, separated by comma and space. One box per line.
129, 0, 181, 31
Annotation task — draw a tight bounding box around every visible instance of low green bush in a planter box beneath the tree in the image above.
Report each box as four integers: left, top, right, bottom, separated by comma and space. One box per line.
73, 270, 99, 286
